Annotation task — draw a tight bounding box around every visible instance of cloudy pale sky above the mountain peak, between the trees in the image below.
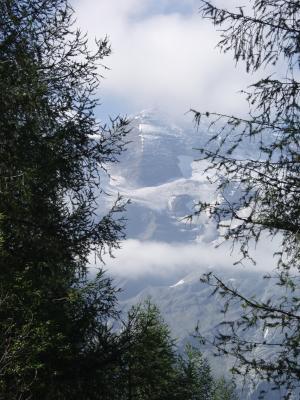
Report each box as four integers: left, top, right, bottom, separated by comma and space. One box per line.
73, 0, 252, 120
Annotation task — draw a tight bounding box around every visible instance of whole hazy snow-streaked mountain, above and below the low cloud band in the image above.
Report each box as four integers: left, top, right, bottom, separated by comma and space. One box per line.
105, 111, 288, 400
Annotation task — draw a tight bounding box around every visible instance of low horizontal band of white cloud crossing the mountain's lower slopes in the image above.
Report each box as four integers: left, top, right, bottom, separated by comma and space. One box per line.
91, 237, 279, 279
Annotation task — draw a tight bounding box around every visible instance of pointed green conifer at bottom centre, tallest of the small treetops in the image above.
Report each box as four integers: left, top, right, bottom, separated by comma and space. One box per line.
117, 300, 176, 400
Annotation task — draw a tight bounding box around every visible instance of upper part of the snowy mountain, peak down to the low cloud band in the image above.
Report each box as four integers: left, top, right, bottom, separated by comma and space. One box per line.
109, 111, 219, 242
